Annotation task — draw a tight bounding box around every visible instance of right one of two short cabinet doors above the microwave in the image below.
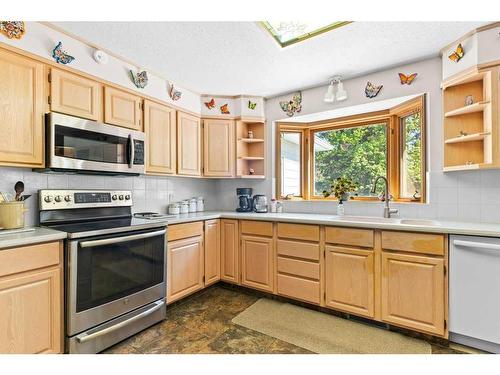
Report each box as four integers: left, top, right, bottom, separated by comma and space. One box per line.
104, 86, 142, 131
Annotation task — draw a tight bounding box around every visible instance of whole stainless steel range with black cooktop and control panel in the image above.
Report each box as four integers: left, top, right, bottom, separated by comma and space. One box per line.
39, 190, 167, 353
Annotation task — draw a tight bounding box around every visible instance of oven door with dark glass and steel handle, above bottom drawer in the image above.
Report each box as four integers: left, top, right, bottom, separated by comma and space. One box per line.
66, 227, 166, 336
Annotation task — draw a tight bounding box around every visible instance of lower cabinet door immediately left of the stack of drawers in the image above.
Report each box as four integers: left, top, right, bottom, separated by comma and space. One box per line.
241, 236, 274, 292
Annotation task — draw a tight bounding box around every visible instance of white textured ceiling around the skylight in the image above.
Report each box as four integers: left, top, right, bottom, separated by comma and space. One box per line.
53, 22, 485, 97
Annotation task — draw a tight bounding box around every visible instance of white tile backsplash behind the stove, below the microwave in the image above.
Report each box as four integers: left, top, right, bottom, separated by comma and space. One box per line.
0, 167, 217, 225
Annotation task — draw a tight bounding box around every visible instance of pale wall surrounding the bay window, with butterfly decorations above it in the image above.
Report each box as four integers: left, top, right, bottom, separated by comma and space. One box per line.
217, 58, 500, 223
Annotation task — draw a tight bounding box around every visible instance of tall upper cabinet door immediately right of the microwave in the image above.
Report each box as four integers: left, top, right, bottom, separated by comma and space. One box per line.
144, 100, 177, 174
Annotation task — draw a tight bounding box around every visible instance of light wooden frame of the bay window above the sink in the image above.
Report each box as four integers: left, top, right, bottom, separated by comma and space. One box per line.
276, 94, 427, 203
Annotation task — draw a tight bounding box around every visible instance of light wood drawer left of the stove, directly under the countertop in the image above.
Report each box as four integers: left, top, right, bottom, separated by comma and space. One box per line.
0, 242, 60, 277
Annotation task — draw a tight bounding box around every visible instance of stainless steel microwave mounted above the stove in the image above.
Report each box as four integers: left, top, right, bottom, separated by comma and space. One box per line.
44, 112, 145, 175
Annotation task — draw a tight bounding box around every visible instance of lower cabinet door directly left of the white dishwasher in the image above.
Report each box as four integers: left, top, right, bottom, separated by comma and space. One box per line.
382, 252, 445, 335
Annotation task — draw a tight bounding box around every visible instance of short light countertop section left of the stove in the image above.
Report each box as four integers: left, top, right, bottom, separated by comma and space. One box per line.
0, 227, 67, 250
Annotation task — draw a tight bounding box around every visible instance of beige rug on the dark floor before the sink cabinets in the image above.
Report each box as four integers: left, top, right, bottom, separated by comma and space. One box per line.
232, 298, 431, 354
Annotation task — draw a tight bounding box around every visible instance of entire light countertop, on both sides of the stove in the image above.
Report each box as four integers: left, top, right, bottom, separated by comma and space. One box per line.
4, 211, 500, 250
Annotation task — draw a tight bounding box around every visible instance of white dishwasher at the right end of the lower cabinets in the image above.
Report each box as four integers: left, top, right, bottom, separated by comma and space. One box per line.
449, 235, 500, 353
